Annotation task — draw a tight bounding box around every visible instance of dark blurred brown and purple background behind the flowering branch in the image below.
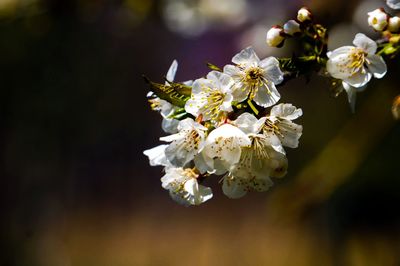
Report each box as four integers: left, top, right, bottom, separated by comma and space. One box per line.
0, 0, 400, 266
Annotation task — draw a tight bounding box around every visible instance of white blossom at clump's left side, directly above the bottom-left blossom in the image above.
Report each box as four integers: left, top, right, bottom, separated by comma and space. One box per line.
160, 118, 207, 167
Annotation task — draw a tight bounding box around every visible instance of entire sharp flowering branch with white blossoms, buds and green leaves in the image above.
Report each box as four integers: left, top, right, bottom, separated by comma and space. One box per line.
144, 0, 400, 206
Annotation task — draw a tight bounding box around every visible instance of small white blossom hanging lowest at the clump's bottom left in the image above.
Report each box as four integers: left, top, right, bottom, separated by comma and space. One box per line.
161, 167, 213, 206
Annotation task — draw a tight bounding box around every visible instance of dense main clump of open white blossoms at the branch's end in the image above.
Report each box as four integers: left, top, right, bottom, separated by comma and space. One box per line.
144, 47, 302, 205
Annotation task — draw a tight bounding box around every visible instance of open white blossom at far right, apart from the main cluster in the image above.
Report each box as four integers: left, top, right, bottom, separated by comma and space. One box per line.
326, 33, 387, 88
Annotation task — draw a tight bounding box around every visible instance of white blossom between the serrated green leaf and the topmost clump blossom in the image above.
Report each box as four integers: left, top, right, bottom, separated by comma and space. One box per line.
185, 71, 234, 121
